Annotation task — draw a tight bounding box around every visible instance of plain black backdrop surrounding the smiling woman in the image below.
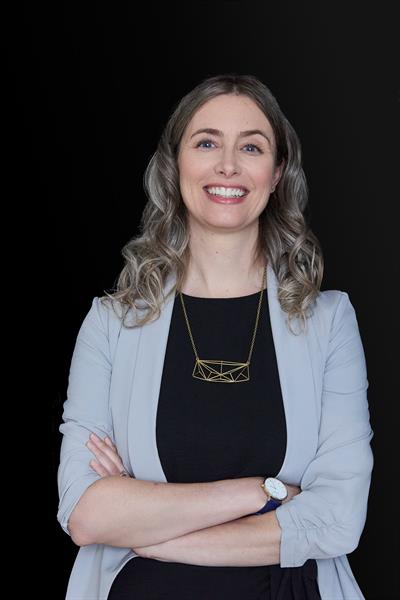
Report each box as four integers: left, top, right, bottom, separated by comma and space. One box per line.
3, 1, 400, 600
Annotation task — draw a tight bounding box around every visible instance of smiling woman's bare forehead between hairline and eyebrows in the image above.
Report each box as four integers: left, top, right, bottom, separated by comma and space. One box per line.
187, 94, 272, 134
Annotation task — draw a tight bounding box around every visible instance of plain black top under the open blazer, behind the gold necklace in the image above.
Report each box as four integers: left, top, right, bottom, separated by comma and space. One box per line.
109, 290, 320, 600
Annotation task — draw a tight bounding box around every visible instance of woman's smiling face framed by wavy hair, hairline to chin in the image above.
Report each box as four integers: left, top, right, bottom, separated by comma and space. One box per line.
178, 95, 281, 231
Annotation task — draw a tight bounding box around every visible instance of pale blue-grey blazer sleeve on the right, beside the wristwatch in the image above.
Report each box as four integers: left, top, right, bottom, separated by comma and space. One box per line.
276, 292, 373, 567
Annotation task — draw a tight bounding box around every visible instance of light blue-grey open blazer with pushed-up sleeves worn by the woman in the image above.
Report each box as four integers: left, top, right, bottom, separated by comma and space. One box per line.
57, 265, 373, 600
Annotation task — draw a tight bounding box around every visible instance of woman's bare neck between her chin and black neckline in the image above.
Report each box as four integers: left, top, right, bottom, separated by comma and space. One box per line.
181, 221, 266, 298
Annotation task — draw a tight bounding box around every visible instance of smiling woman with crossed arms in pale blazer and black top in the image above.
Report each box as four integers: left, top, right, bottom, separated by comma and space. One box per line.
58, 75, 373, 600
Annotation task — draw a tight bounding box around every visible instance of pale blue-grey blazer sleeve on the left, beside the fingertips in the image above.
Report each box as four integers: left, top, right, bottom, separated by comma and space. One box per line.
57, 298, 112, 534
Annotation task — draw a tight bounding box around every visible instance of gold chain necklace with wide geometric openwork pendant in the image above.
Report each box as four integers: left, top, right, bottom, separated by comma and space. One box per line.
179, 269, 267, 383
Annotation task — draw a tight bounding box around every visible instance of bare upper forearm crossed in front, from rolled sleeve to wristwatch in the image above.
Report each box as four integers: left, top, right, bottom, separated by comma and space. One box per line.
69, 476, 272, 548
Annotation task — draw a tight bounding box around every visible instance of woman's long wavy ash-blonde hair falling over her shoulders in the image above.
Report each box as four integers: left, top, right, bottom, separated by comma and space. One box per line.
102, 74, 324, 333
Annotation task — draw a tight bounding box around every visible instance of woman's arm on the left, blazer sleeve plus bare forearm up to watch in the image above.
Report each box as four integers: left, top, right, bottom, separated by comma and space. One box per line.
58, 299, 274, 547
